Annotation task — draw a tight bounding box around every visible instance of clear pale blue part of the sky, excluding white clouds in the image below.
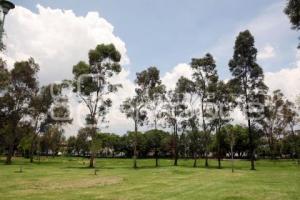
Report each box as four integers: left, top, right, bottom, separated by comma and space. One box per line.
14, 0, 297, 78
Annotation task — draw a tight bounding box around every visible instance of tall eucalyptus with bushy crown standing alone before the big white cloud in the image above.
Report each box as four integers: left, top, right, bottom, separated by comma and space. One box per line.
73, 44, 121, 167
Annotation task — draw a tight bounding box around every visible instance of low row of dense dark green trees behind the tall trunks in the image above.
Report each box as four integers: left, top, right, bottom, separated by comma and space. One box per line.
63, 125, 300, 168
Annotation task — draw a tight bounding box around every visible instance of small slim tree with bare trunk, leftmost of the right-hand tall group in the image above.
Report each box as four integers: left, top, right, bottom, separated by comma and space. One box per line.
121, 94, 147, 168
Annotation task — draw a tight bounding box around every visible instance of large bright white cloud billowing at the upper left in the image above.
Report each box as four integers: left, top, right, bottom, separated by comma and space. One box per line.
1, 5, 129, 83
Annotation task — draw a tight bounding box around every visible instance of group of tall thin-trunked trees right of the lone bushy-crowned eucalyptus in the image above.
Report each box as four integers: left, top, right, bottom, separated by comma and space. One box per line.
121, 30, 299, 169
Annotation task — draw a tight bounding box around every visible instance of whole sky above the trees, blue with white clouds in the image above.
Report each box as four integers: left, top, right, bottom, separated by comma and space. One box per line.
2, 0, 300, 135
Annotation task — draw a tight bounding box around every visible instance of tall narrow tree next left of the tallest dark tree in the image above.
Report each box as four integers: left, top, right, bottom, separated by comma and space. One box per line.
191, 53, 218, 167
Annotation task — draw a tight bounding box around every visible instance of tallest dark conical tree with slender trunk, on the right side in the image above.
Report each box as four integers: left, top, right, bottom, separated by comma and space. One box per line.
229, 30, 267, 170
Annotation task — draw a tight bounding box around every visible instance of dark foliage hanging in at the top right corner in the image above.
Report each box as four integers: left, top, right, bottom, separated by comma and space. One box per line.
284, 0, 300, 48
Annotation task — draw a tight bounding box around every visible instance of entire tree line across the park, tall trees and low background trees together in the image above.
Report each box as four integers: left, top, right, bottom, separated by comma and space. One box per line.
0, 31, 299, 169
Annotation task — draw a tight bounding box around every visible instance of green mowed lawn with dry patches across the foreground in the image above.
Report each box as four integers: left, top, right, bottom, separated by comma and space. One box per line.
0, 158, 300, 200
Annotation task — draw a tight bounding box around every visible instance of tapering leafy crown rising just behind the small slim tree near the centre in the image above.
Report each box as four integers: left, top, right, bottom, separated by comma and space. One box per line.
135, 67, 166, 129
